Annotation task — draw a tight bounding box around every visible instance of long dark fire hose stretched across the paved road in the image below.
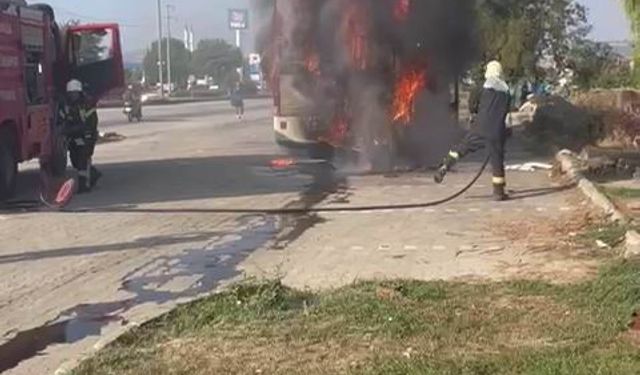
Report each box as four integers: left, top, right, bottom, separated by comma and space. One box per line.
0, 156, 490, 215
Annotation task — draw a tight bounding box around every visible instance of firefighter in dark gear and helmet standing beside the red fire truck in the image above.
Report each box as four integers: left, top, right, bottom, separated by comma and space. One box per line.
60, 79, 102, 193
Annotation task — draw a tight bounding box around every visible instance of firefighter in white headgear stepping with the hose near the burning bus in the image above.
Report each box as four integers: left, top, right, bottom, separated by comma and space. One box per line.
434, 61, 511, 201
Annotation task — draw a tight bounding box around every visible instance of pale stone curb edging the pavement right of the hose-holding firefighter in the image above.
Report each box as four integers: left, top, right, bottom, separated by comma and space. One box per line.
556, 150, 640, 259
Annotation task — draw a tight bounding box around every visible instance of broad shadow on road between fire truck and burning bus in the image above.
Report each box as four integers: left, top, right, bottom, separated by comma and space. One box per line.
8, 155, 311, 209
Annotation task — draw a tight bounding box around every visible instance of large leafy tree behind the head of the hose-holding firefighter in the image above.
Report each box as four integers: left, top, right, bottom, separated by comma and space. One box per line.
477, 0, 591, 78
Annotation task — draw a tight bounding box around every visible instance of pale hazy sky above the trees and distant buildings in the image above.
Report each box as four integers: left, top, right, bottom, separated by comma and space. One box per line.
44, 0, 629, 58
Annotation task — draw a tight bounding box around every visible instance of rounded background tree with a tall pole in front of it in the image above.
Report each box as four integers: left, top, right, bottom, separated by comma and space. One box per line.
143, 38, 191, 84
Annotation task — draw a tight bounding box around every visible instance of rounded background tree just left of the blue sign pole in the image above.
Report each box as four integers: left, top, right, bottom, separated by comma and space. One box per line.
191, 39, 242, 88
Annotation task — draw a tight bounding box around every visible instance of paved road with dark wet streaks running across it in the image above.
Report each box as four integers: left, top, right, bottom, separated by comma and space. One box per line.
0, 100, 596, 375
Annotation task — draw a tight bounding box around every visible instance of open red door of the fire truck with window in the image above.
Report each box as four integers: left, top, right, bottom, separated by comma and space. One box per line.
66, 24, 124, 100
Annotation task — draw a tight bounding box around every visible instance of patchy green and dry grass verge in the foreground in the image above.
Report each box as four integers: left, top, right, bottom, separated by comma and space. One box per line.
73, 261, 640, 375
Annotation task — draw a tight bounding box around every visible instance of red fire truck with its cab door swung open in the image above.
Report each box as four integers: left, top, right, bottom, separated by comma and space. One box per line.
0, 0, 124, 201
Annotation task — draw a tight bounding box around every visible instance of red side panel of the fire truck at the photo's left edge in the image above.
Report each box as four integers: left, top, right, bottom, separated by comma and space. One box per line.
0, 7, 27, 159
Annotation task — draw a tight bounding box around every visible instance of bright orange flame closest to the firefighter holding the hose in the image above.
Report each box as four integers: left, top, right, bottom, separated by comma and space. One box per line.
392, 68, 427, 124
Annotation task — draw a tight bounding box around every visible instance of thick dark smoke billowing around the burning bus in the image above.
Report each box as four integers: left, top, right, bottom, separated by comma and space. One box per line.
254, 0, 478, 167
